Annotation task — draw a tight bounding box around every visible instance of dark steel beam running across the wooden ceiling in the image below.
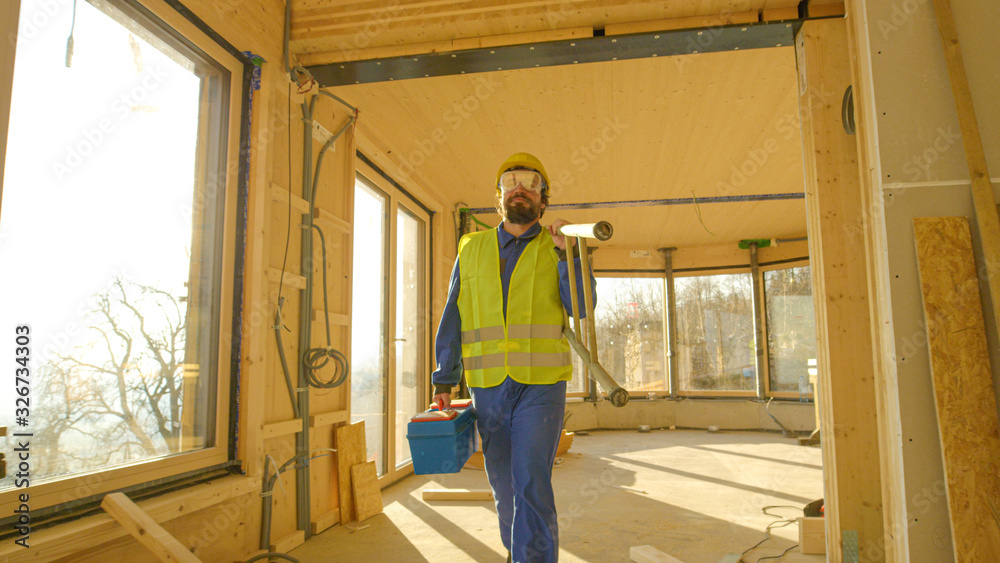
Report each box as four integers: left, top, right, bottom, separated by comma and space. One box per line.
307, 19, 806, 88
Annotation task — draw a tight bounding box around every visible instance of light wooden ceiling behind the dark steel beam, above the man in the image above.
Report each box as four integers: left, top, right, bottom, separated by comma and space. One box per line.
330, 48, 806, 248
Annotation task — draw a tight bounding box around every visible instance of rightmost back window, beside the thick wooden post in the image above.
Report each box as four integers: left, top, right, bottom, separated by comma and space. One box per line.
764, 266, 816, 393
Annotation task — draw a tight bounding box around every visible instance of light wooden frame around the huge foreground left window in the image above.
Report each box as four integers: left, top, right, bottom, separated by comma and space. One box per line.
0, 0, 252, 521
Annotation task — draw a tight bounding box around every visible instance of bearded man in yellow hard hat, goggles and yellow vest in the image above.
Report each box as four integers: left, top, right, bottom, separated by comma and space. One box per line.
432, 153, 596, 563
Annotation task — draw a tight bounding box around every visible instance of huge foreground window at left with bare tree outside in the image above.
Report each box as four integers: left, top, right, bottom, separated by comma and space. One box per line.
0, 0, 243, 514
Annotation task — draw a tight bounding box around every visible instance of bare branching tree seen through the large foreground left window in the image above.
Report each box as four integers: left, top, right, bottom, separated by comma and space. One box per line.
14, 279, 204, 479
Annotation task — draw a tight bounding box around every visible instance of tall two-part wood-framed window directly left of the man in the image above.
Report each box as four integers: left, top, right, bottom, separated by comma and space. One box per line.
351, 165, 429, 481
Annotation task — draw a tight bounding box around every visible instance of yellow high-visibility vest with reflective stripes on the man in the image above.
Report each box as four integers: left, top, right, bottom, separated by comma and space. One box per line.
458, 229, 573, 387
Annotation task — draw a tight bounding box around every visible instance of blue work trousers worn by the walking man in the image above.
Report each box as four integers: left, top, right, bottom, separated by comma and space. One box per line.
472, 377, 566, 563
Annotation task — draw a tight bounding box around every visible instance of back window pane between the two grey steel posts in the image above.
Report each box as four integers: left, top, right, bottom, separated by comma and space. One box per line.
674, 274, 756, 392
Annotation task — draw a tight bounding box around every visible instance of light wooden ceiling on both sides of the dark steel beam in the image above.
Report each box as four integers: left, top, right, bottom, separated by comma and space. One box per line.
292, 0, 816, 249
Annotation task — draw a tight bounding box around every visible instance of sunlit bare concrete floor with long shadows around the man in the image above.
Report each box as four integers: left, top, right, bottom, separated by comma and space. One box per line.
290, 430, 825, 563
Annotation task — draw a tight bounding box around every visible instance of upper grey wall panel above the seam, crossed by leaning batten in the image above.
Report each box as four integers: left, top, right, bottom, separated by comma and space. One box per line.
866, 0, 1000, 183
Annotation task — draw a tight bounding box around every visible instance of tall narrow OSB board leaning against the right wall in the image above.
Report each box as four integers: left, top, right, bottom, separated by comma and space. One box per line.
913, 217, 1000, 561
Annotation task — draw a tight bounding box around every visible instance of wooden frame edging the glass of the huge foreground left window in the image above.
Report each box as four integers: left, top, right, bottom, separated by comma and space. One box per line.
0, 0, 244, 514
